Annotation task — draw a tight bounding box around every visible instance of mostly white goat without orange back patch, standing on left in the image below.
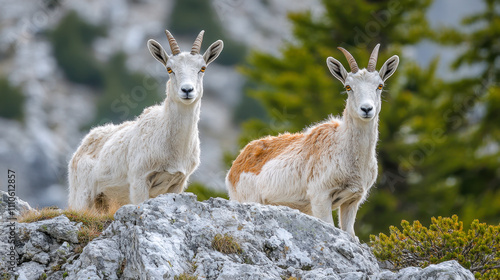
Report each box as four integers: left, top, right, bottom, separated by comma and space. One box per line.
68, 30, 223, 209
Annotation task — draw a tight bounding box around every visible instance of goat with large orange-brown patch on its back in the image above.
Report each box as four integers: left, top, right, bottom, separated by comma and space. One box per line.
226, 45, 399, 236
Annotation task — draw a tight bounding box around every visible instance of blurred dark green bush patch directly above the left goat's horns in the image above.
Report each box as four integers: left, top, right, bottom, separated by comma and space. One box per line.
168, 0, 246, 65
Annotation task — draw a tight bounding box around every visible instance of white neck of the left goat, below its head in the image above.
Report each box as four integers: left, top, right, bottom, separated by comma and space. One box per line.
164, 82, 201, 151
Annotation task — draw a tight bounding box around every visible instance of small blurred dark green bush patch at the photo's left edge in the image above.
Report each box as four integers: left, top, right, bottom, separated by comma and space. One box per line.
0, 77, 25, 120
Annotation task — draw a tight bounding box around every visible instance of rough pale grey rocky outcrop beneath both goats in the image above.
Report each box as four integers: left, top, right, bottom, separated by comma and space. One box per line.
0, 193, 474, 279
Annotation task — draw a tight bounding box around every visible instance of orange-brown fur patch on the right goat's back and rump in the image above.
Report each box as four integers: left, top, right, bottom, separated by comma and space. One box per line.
228, 133, 304, 188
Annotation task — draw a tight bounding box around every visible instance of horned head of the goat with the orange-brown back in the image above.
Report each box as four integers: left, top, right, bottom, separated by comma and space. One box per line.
326, 44, 399, 121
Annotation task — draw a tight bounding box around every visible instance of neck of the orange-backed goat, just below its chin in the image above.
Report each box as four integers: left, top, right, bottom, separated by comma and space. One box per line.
339, 109, 378, 160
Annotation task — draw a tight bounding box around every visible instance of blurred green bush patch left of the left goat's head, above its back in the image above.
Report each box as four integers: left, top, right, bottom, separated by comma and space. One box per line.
50, 12, 162, 126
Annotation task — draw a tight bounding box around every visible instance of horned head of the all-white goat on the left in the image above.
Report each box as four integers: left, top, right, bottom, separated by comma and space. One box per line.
148, 30, 224, 104
